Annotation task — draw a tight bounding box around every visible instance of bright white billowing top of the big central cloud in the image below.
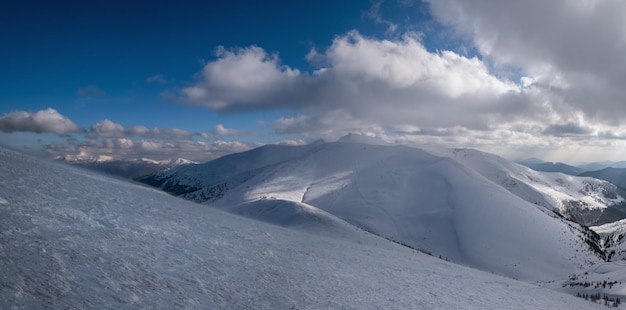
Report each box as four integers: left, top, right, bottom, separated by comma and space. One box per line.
326, 31, 517, 99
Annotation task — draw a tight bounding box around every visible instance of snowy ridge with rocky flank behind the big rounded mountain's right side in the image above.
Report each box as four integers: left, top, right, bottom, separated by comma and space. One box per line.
431, 149, 626, 226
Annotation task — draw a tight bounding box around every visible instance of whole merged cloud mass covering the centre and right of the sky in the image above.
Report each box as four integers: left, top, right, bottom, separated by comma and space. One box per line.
169, 17, 626, 162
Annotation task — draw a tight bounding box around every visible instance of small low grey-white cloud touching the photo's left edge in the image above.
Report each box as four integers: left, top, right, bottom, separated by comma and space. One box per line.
0, 108, 85, 134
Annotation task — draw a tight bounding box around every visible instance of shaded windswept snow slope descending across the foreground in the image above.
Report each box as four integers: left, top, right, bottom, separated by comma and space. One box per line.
0, 148, 601, 309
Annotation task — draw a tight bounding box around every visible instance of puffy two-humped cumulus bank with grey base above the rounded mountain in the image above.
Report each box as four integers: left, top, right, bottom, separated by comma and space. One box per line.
180, 31, 528, 132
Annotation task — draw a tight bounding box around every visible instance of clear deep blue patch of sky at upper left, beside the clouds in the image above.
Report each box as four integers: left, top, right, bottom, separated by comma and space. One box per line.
0, 1, 369, 127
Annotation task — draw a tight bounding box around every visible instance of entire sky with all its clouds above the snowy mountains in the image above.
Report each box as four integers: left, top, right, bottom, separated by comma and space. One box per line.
0, 0, 626, 162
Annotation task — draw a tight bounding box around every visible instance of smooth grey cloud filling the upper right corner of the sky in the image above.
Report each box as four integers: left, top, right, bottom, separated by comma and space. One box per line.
428, 0, 626, 125
